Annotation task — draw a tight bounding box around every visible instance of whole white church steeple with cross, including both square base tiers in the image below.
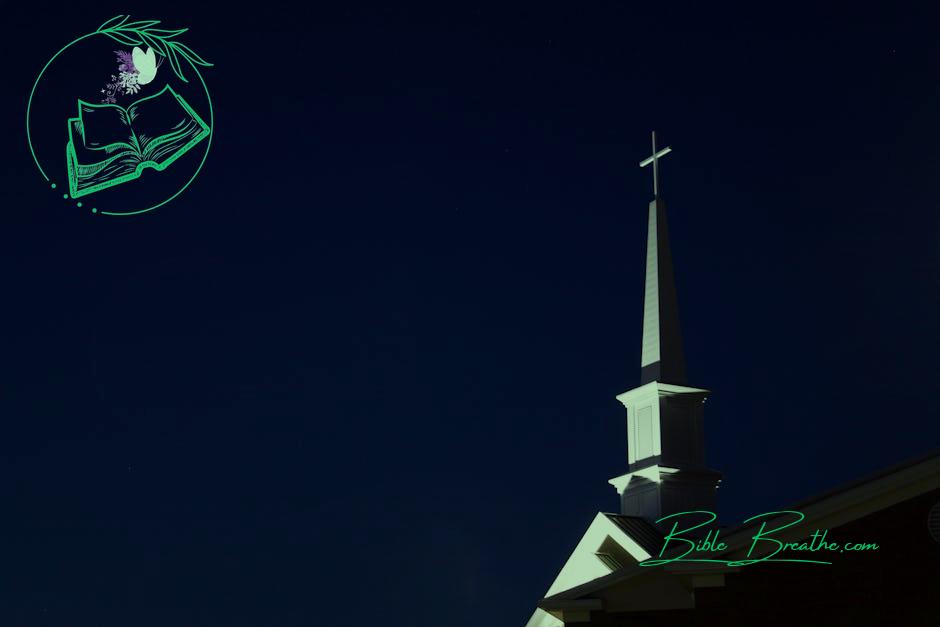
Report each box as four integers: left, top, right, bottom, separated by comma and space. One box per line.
610, 133, 721, 520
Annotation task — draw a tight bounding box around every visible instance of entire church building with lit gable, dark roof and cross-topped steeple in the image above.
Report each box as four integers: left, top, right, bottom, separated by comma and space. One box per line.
526, 134, 940, 627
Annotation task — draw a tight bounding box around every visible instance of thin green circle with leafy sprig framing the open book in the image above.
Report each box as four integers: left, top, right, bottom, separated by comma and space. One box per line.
26, 15, 215, 216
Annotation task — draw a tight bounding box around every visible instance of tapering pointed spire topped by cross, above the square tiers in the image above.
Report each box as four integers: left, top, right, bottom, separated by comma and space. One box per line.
640, 132, 686, 385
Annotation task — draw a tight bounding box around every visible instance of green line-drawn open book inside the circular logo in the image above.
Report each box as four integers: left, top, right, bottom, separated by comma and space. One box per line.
66, 85, 210, 198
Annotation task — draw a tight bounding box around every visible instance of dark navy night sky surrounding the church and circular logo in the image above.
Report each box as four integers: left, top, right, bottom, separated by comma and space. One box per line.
0, 0, 940, 627
